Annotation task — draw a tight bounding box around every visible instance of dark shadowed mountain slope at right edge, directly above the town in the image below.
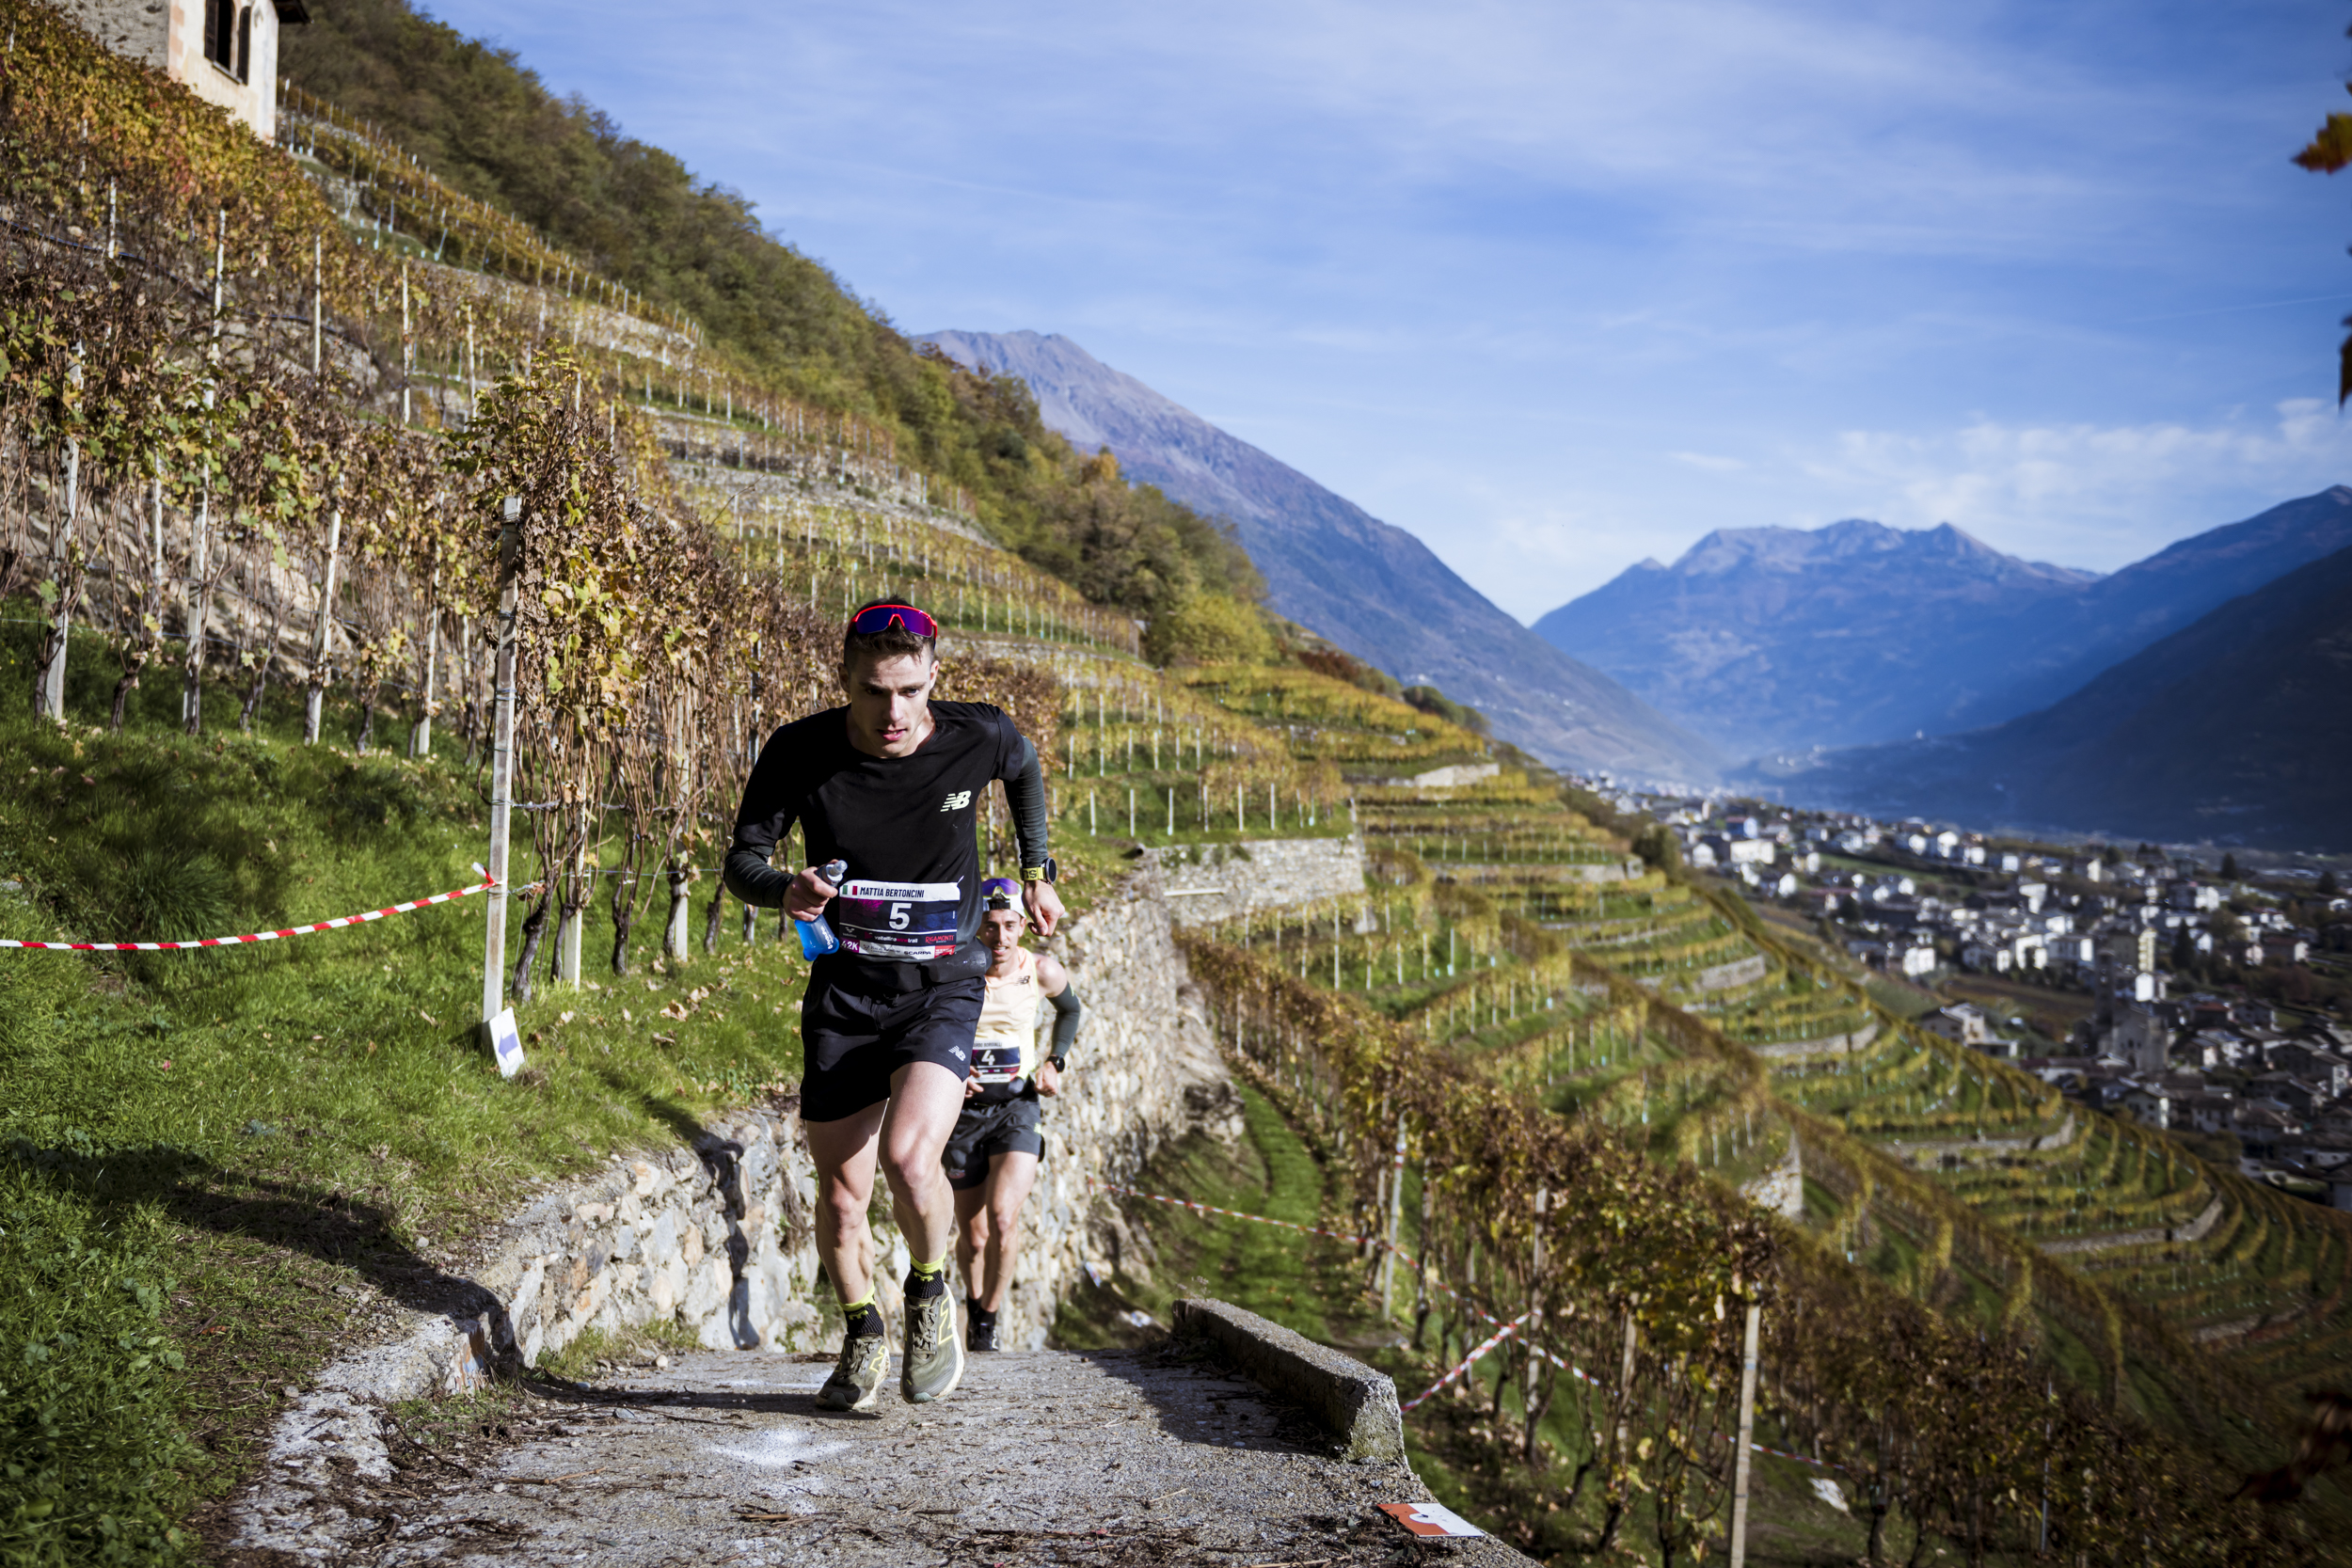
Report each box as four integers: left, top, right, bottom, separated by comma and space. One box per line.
1757, 545, 2352, 851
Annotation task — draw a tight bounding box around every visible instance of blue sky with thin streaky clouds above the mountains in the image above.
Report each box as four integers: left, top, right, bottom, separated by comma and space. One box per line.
414, 0, 2352, 618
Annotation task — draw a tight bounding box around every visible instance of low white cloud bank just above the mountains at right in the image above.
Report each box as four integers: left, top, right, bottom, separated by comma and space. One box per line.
1800, 397, 2352, 571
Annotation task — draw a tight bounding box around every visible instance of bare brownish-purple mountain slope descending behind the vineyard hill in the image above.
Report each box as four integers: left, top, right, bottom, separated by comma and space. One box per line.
920, 331, 1722, 783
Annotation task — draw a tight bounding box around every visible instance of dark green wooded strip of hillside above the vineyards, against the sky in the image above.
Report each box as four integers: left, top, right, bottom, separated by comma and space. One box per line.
280, 0, 1263, 643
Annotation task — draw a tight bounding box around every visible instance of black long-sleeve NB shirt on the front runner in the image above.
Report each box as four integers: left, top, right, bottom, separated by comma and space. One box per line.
727, 703, 1047, 961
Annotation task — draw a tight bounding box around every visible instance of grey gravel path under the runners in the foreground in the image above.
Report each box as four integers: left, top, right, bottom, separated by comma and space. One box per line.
238, 1347, 1527, 1568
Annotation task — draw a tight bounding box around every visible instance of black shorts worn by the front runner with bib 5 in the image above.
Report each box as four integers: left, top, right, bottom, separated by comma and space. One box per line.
800, 959, 988, 1121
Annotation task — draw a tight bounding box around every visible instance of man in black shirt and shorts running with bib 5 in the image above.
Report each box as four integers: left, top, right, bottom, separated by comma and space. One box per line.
727, 599, 1061, 1411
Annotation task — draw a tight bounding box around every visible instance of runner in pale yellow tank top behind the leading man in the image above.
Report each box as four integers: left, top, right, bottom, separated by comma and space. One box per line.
941, 877, 1080, 1350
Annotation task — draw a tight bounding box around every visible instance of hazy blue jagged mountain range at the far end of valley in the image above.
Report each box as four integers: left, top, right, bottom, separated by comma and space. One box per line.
1536, 484, 2352, 757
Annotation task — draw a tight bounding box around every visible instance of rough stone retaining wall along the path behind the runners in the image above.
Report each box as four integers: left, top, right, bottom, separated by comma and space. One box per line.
255, 867, 1242, 1465
